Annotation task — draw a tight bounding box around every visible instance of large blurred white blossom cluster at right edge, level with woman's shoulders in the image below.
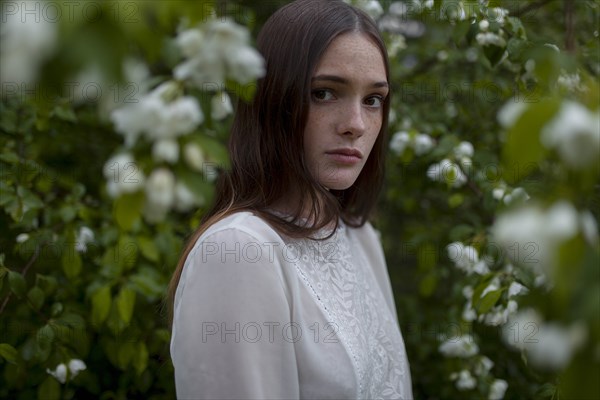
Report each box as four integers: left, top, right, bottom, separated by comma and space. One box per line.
492, 201, 598, 281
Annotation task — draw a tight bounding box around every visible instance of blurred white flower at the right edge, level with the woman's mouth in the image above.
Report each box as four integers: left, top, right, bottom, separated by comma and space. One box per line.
541, 101, 600, 169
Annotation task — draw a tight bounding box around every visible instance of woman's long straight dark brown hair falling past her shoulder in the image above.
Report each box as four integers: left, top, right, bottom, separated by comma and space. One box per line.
168, 0, 390, 318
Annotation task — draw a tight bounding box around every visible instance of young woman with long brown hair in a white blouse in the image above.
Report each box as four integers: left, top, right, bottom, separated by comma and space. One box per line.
171, 0, 412, 399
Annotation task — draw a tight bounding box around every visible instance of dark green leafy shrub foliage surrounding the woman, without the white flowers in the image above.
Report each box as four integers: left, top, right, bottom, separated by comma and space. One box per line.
0, 0, 600, 399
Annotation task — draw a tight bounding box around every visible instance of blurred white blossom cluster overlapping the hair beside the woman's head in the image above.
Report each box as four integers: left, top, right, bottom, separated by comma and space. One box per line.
173, 20, 265, 90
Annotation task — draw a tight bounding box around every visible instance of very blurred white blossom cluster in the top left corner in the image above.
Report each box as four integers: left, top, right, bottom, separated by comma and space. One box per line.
0, 1, 58, 88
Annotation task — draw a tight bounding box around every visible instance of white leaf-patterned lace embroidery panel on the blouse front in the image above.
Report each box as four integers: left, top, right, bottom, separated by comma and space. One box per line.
291, 223, 407, 399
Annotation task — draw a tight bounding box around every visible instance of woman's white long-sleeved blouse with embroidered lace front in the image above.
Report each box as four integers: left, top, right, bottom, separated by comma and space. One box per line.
171, 212, 412, 399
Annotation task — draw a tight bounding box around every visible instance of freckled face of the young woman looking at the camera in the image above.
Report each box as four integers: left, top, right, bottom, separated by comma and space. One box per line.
304, 33, 389, 190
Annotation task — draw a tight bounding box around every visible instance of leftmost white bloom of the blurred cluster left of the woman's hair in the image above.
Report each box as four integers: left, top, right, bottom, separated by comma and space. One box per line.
103, 153, 145, 198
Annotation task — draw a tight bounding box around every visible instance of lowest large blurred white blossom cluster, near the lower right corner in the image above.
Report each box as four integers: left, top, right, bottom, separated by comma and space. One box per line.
502, 308, 587, 370
